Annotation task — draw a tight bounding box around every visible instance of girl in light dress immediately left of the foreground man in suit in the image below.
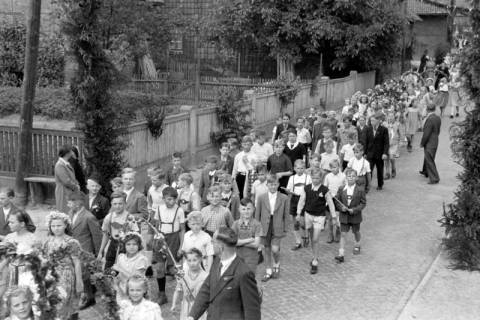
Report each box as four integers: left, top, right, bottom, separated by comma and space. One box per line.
170, 248, 208, 320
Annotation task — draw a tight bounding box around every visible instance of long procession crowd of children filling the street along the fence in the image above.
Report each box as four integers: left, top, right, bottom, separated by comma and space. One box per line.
0, 68, 458, 320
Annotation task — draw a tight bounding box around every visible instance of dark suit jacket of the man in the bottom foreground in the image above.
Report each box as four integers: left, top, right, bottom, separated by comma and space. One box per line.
189, 256, 261, 320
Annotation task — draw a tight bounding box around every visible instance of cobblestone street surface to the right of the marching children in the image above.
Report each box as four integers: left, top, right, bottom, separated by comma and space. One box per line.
27, 114, 459, 320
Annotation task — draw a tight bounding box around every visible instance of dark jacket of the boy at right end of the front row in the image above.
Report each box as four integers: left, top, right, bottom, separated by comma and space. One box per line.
334, 186, 367, 224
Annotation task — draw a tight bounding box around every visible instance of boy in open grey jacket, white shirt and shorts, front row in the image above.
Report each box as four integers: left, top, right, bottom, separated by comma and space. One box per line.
255, 174, 290, 282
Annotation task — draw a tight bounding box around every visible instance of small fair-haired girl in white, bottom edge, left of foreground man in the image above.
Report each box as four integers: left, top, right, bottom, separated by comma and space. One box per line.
119, 274, 163, 320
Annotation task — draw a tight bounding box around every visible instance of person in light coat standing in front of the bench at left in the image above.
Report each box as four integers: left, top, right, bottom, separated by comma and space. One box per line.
55, 145, 80, 213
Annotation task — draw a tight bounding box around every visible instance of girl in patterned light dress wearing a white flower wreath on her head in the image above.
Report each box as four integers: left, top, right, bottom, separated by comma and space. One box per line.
43, 211, 83, 320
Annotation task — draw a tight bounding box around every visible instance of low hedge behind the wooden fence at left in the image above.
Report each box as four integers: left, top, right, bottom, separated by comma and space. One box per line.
0, 87, 179, 122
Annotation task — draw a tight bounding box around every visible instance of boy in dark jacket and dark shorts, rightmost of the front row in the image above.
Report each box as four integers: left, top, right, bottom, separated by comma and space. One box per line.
335, 169, 367, 263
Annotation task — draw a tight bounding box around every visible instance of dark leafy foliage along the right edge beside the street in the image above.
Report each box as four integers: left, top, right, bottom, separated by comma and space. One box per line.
441, 0, 480, 270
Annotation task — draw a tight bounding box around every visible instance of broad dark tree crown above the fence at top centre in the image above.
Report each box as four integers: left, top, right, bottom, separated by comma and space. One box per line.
209, 0, 404, 71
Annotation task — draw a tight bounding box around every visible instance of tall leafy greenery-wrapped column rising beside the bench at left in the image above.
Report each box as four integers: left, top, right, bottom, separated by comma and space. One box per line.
58, 0, 126, 195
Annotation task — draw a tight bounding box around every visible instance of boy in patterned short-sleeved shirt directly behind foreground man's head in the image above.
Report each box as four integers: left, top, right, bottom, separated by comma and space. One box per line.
232, 198, 262, 273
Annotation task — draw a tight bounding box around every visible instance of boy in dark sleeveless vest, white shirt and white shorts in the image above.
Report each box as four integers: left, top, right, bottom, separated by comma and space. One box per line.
296, 170, 337, 274
